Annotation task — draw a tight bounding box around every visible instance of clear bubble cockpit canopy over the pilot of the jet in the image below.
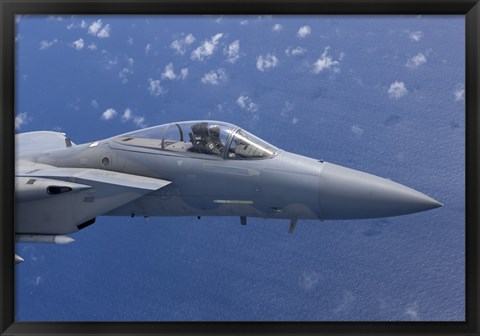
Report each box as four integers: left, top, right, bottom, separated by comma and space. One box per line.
113, 121, 278, 159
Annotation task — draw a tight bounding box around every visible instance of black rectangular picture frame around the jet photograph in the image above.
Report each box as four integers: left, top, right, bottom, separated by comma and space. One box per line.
0, 0, 480, 335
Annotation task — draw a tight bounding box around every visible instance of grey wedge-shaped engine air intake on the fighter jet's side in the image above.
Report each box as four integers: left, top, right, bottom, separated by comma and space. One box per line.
15, 163, 171, 235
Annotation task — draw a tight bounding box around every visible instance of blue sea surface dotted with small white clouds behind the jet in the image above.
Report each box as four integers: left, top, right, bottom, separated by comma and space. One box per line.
15, 16, 465, 321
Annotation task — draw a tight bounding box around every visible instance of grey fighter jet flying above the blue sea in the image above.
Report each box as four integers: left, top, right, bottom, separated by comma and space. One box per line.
15, 120, 441, 262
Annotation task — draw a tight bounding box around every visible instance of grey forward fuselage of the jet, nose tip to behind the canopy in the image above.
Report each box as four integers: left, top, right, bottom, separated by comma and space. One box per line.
25, 122, 440, 220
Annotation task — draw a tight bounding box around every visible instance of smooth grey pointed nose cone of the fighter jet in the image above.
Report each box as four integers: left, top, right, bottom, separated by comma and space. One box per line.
320, 163, 442, 219
